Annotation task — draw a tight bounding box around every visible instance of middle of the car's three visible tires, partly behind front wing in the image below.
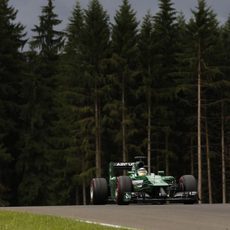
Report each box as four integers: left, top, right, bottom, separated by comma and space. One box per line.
116, 176, 132, 205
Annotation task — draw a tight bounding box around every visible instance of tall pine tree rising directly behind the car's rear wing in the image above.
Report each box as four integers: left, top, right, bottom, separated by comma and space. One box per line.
112, 0, 140, 161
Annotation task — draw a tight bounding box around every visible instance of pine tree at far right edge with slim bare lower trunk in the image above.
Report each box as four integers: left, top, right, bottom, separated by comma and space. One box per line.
214, 18, 230, 203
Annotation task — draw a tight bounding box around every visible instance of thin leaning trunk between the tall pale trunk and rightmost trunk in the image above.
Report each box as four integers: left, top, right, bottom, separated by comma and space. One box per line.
205, 112, 212, 204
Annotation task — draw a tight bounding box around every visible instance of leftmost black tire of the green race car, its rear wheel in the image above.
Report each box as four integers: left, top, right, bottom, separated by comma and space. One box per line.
90, 178, 108, 205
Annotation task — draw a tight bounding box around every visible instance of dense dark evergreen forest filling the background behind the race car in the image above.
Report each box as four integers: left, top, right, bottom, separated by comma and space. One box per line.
0, 0, 230, 206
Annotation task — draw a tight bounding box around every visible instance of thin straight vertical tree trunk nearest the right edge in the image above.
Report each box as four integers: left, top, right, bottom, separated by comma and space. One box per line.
221, 101, 226, 204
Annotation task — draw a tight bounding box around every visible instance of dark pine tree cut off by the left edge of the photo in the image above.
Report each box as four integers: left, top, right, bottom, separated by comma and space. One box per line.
0, 0, 25, 205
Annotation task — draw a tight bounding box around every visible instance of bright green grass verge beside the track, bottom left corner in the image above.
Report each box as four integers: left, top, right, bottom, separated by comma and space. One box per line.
0, 211, 125, 230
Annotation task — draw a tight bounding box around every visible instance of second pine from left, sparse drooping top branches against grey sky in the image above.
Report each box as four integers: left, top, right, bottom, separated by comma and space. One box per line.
18, 0, 64, 205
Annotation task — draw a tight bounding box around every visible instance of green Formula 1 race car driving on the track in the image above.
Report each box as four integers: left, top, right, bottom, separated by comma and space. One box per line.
90, 160, 198, 205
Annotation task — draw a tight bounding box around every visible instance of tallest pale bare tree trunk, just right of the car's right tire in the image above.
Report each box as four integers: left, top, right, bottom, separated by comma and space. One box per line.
197, 41, 202, 203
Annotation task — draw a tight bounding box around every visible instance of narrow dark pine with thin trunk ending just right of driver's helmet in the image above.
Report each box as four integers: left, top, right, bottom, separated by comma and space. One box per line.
136, 12, 155, 170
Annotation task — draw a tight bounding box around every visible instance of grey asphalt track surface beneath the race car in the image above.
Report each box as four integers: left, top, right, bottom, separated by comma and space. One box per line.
0, 204, 230, 230
